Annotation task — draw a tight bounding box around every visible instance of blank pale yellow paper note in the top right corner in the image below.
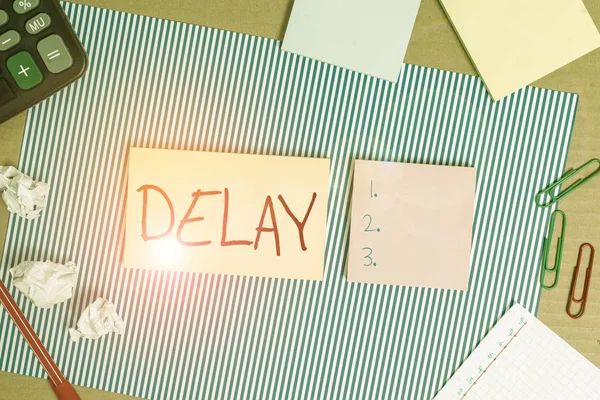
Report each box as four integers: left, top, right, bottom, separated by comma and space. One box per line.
440, 0, 600, 101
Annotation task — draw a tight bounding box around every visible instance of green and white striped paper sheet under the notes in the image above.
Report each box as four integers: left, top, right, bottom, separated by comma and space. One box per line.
0, 3, 577, 400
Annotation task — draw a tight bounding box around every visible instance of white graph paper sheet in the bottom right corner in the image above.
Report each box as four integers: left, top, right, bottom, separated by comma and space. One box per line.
434, 304, 600, 400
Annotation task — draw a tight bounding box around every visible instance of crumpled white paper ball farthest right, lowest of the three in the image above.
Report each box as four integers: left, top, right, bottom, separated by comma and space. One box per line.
69, 297, 125, 342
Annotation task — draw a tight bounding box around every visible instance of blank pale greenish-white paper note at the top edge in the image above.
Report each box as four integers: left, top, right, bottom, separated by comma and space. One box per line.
282, 0, 421, 82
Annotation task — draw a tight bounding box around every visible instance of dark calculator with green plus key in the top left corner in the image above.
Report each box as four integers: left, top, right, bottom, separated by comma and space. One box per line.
0, 0, 88, 123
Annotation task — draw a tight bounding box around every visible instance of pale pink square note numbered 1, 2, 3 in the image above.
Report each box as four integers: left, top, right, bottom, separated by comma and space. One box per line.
347, 161, 476, 290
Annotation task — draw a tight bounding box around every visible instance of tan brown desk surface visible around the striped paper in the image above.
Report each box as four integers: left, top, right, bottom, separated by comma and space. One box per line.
0, 0, 600, 400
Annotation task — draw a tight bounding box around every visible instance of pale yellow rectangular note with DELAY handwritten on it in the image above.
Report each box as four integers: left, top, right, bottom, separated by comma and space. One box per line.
124, 148, 329, 280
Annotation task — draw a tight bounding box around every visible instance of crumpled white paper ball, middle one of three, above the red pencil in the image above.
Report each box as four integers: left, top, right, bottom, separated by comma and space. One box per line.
9, 261, 79, 308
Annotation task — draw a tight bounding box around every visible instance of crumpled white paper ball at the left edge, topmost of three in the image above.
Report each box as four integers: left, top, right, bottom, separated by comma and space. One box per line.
0, 166, 50, 219
